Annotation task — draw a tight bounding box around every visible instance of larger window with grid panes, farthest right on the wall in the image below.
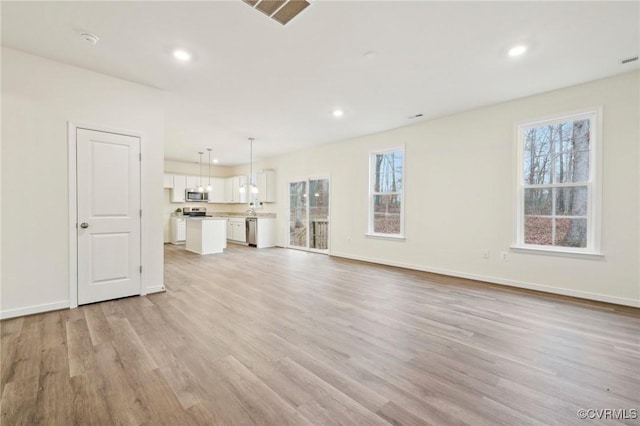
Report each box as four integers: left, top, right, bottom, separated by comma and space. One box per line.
517, 111, 599, 253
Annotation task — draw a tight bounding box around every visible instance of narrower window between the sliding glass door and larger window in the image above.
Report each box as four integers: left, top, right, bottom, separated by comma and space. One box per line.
368, 148, 404, 238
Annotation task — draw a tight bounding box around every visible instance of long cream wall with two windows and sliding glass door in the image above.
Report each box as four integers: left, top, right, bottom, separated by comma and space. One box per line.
273, 72, 640, 306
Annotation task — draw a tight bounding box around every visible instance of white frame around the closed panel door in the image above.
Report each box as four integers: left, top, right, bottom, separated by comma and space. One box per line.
67, 121, 149, 309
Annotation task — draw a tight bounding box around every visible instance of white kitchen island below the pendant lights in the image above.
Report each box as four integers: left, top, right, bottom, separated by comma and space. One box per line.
185, 216, 227, 254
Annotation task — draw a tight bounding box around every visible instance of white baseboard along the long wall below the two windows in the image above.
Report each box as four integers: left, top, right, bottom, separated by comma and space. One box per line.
331, 252, 640, 308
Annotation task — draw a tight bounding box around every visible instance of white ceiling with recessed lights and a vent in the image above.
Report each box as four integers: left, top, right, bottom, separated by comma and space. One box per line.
2, 0, 640, 165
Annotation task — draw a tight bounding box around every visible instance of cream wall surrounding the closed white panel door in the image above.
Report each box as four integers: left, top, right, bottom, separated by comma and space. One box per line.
0, 48, 164, 318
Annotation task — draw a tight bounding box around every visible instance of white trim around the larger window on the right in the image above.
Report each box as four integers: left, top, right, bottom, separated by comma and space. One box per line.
510, 106, 603, 258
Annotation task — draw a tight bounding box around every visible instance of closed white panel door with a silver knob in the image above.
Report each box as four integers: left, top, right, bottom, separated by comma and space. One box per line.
76, 129, 140, 305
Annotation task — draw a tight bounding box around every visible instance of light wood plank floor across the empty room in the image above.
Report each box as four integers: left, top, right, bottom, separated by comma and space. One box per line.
1, 246, 640, 426
